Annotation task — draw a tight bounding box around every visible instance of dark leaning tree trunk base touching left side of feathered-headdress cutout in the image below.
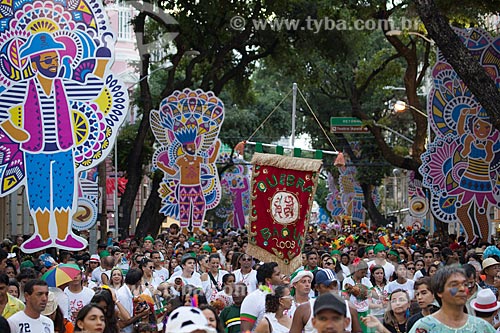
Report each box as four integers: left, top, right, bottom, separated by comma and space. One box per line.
135, 171, 165, 238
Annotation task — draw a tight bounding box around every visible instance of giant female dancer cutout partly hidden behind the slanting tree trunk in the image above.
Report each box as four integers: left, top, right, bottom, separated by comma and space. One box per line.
419, 29, 500, 242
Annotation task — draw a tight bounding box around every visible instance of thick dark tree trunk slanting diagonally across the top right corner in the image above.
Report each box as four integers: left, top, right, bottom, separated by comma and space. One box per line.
415, 0, 500, 130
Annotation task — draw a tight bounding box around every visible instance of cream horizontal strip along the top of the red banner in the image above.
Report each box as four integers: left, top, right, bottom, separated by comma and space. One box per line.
252, 153, 323, 172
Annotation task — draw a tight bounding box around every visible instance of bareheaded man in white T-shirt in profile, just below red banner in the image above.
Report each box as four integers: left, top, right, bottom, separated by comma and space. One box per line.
240, 262, 283, 332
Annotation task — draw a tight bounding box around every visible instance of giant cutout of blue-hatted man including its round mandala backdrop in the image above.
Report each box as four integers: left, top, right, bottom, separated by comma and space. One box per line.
0, 0, 128, 253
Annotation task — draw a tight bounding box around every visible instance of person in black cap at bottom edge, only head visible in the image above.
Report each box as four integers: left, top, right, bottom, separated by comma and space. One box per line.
312, 293, 350, 333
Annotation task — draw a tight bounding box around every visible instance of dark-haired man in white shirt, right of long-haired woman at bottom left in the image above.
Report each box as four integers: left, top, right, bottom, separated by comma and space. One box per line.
116, 268, 149, 333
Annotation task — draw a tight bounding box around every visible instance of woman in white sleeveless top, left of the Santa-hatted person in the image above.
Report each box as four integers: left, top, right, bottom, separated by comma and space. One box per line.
255, 286, 293, 333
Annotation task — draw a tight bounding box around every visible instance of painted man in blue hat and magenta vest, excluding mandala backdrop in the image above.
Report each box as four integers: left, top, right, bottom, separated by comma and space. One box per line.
4, 30, 111, 253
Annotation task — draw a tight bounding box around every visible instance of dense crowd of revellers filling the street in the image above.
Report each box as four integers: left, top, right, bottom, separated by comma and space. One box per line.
0, 225, 500, 333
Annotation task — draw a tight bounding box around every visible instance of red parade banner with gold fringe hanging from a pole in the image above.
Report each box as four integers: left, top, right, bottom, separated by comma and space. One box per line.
247, 153, 322, 274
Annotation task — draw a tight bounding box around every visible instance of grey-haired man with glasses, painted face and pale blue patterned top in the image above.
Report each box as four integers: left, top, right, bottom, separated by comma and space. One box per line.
409, 265, 496, 333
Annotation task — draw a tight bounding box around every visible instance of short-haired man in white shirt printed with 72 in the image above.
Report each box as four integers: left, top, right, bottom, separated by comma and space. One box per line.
8, 280, 54, 333
